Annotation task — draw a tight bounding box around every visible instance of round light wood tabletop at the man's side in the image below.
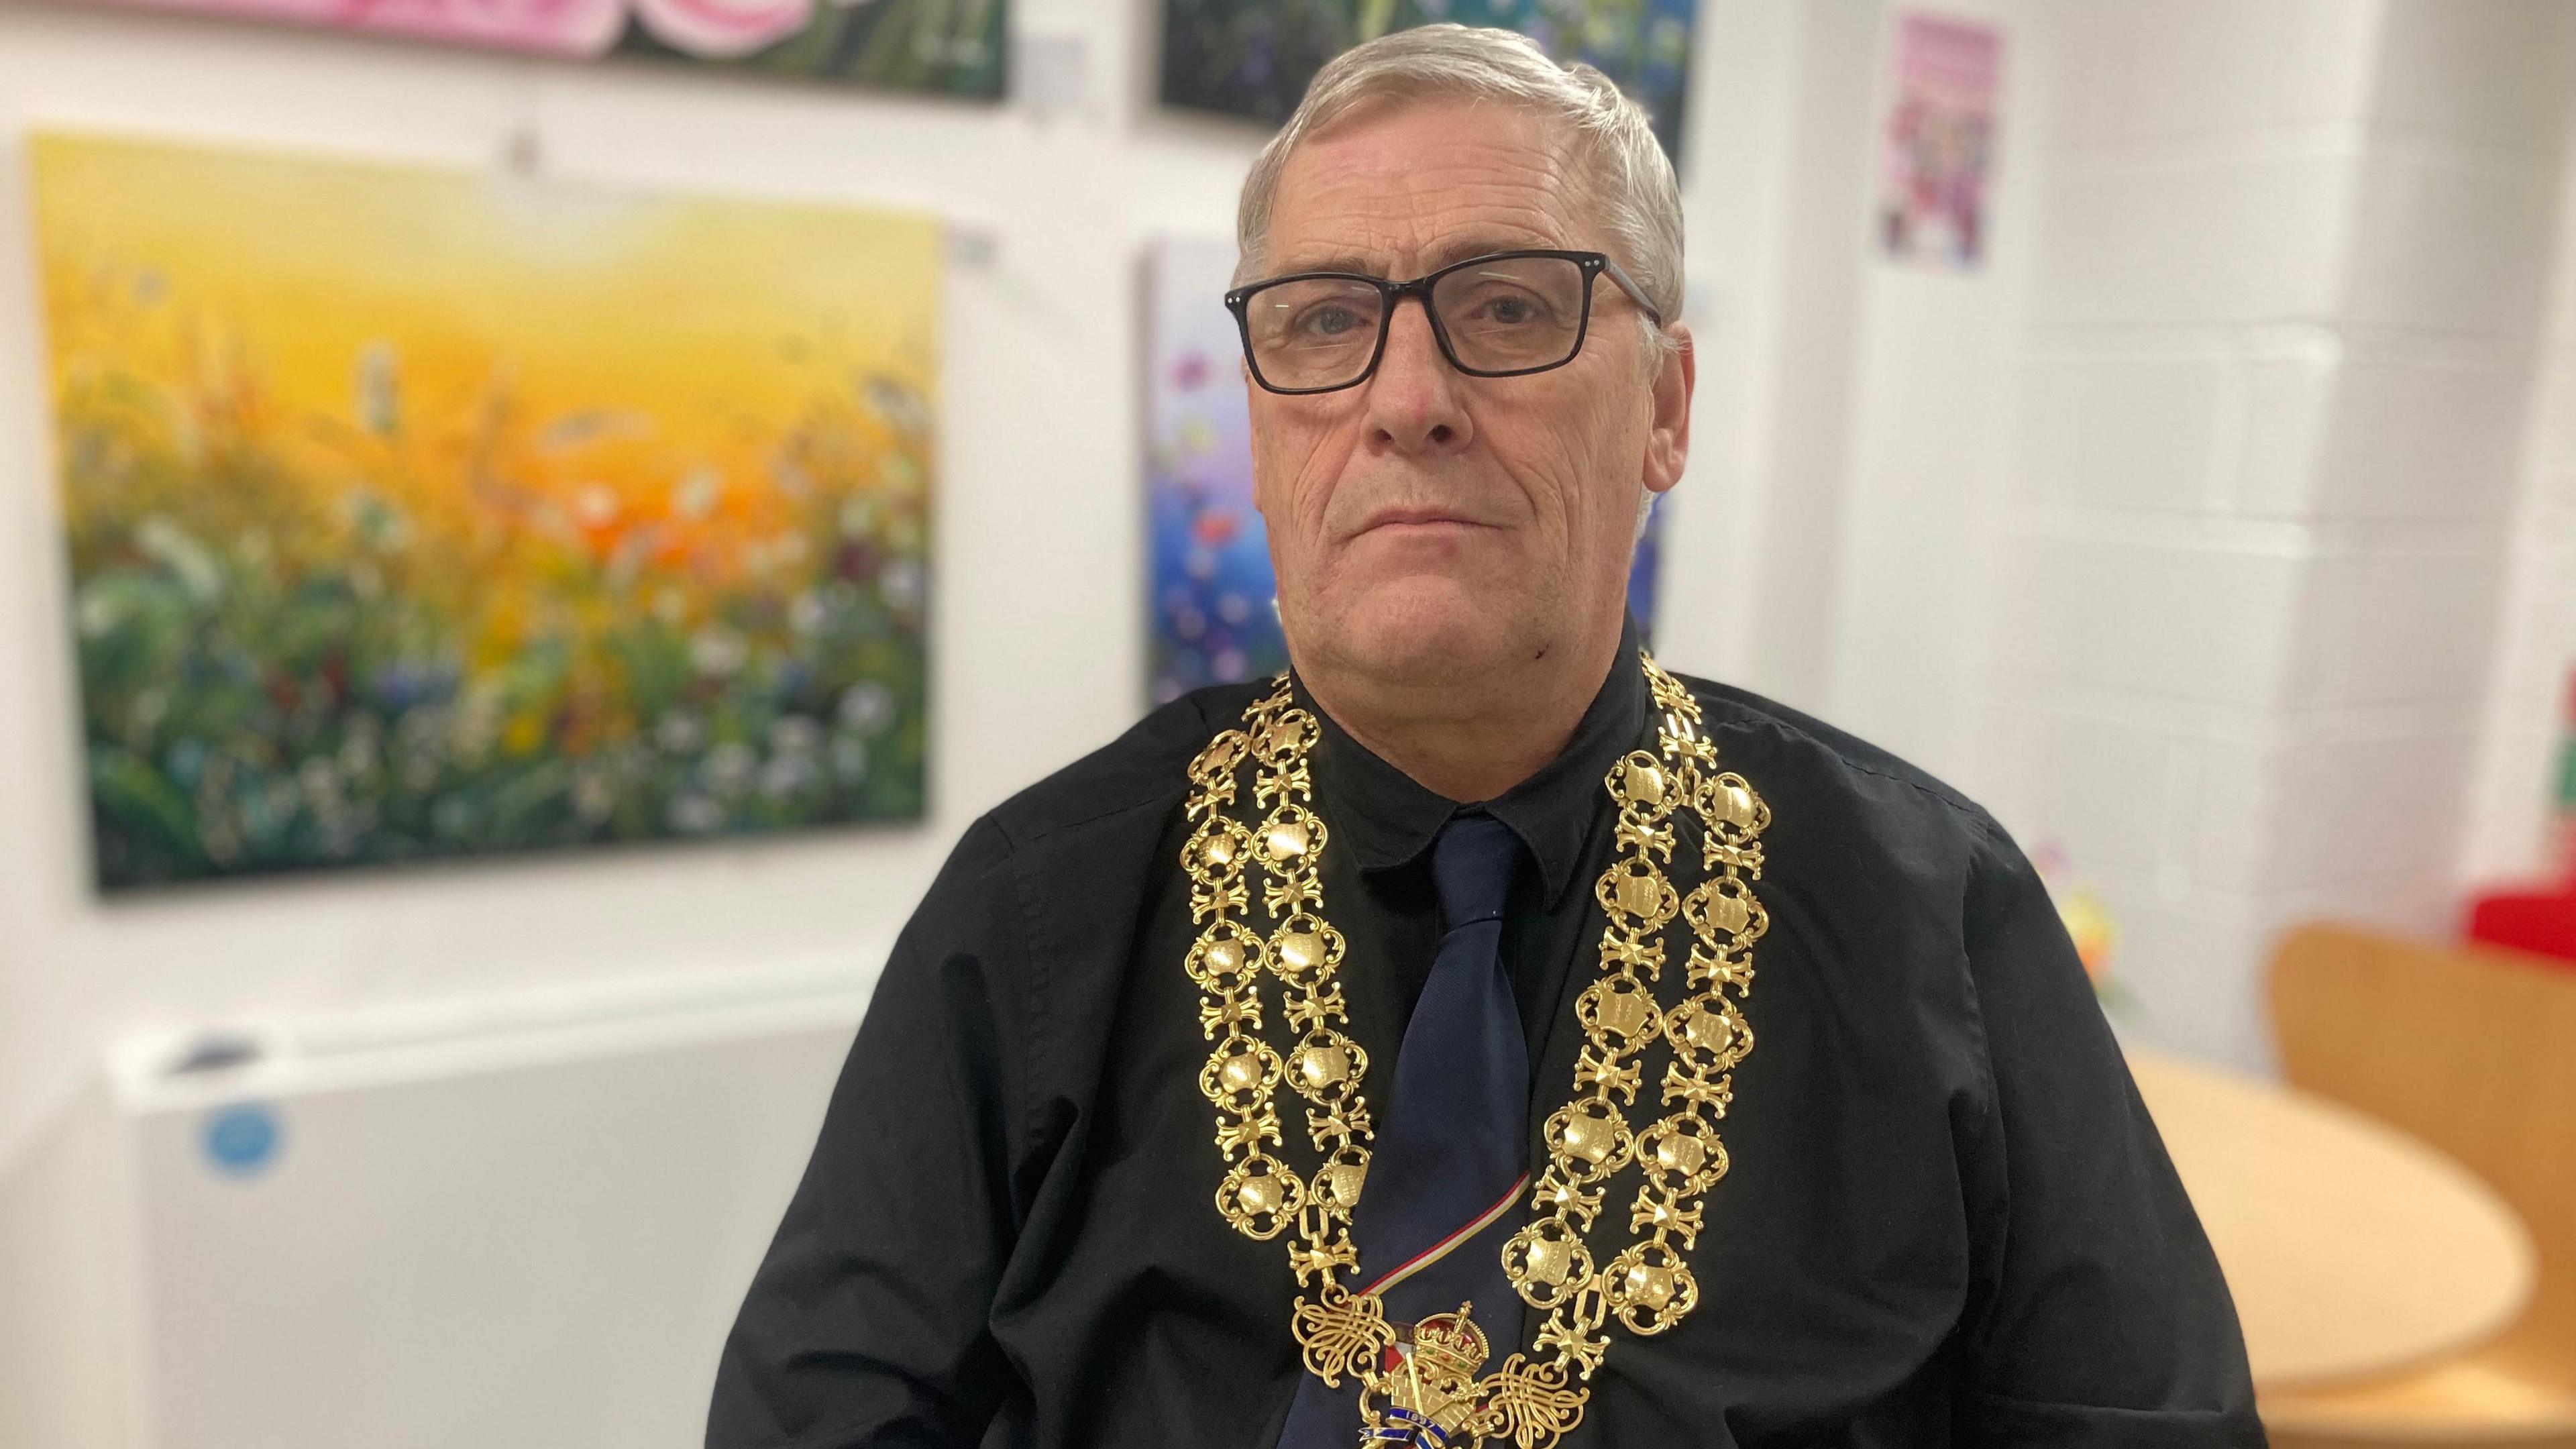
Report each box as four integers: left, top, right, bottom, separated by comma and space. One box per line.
2128, 1052, 2537, 1387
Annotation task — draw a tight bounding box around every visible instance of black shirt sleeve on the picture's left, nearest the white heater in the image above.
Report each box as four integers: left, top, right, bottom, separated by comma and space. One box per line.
706, 822, 1025, 1449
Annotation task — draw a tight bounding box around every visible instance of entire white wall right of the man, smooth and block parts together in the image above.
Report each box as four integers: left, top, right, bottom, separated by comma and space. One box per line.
1666, 0, 2576, 1067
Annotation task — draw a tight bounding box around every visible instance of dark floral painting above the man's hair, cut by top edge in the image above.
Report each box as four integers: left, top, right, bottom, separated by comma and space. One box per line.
1162, 0, 1698, 160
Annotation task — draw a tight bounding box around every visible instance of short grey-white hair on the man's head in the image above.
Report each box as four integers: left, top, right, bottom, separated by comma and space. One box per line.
1234, 23, 1682, 348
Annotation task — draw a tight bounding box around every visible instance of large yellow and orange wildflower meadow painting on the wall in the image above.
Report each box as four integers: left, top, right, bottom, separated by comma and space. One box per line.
31, 131, 941, 892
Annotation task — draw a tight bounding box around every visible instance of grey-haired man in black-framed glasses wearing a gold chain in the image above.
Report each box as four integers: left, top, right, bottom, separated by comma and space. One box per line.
708, 25, 2262, 1449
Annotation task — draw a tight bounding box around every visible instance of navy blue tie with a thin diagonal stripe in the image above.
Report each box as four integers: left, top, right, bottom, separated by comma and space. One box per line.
1280, 812, 1530, 1449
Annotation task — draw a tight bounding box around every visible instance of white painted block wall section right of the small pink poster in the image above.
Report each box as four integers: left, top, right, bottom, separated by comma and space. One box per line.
1988, 0, 2571, 1065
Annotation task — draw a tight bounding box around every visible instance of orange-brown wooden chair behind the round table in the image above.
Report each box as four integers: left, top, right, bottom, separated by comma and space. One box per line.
2259, 926, 2576, 1449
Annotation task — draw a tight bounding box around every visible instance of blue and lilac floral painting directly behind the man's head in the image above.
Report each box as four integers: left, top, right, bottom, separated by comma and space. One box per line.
1144, 237, 1669, 704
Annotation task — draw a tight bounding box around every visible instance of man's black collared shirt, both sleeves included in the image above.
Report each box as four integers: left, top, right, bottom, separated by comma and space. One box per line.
708, 634, 2262, 1449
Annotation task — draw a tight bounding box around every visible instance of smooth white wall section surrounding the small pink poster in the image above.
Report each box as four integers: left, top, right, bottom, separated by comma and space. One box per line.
1662, 0, 2048, 794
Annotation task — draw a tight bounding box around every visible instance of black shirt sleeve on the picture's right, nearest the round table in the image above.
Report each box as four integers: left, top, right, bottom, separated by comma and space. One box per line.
1957, 822, 2264, 1449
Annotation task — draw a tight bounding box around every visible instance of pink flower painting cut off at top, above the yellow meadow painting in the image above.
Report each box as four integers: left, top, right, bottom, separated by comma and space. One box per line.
68, 0, 1010, 98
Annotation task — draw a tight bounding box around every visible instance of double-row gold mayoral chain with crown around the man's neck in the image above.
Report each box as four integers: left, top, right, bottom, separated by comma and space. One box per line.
1183, 650, 1770, 1449
